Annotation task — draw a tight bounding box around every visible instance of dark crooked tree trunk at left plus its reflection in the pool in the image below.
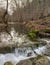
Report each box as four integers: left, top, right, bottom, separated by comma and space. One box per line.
3, 0, 12, 37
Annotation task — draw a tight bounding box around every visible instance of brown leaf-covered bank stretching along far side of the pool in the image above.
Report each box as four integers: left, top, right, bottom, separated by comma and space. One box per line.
0, 17, 50, 30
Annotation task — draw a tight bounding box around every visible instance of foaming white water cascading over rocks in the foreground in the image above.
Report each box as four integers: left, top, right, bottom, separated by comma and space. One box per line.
0, 46, 45, 65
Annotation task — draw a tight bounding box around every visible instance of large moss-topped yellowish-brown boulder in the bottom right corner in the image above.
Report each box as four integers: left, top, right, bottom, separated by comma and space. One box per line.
30, 55, 50, 65
